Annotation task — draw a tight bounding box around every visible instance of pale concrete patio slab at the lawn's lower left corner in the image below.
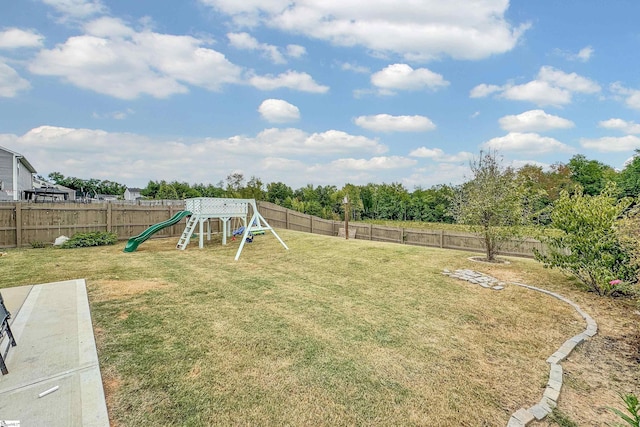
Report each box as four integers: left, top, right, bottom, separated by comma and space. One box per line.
0, 279, 109, 427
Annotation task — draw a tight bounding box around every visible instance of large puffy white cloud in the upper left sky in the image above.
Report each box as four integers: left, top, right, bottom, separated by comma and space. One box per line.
29, 18, 242, 99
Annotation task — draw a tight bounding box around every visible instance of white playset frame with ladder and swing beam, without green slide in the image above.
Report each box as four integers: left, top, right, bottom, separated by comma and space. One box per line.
176, 197, 289, 261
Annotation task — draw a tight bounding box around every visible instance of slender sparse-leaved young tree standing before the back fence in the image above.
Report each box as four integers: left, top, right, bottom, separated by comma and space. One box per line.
451, 151, 531, 262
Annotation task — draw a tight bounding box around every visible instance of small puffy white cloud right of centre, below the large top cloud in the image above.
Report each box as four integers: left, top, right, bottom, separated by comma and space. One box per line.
371, 64, 449, 94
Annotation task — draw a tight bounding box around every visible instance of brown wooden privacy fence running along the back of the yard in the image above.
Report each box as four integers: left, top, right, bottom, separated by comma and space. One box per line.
0, 201, 543, 257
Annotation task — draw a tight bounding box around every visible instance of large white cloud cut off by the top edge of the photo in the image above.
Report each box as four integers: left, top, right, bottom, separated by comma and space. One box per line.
200, 0, 529, 61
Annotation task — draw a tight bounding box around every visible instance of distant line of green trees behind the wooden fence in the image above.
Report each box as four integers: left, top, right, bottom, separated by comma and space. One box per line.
49, 152, 640, 223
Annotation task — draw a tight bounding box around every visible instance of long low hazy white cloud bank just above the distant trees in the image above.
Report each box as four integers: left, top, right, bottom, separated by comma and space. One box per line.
10, 126, 388, 186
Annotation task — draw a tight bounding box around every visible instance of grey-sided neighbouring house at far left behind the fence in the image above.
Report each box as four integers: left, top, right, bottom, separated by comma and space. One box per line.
0, 147, 36, 201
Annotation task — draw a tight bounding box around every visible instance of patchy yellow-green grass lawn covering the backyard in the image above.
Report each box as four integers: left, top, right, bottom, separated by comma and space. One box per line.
0, 230, 640, 426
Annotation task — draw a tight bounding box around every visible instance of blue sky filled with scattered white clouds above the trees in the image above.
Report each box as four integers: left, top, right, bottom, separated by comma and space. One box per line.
0, 0, 640, 190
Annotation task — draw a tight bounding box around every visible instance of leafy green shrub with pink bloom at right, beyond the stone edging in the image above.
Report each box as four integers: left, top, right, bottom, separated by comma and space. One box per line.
534, 183, 638, 295
